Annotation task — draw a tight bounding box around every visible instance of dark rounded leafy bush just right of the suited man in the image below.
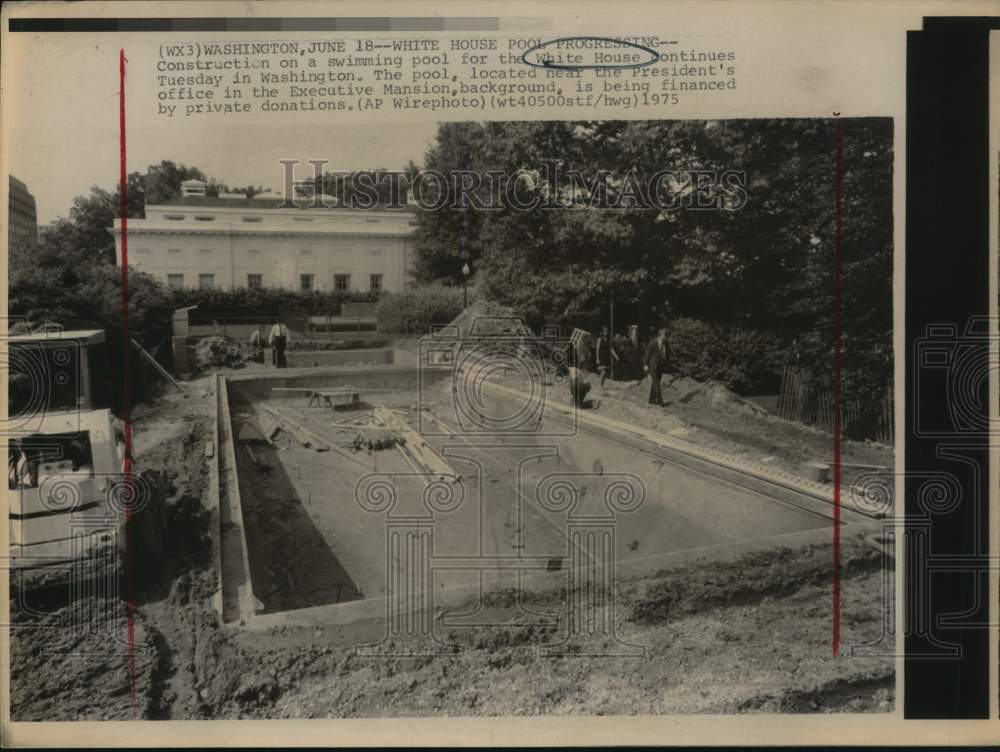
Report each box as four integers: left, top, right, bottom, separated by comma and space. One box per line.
667, 318, 784, 394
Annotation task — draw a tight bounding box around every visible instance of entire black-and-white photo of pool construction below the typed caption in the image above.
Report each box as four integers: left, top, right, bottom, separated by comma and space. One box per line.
7, 110, 896, 721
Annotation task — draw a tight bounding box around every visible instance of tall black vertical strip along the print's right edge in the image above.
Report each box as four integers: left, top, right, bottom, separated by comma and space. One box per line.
901, 19, 997, 719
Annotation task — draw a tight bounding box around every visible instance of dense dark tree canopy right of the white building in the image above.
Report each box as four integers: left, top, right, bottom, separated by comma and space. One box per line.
417, 118, 893, 396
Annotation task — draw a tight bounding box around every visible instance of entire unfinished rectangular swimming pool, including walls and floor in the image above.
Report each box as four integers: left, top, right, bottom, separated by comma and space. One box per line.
213, 365, 867, 626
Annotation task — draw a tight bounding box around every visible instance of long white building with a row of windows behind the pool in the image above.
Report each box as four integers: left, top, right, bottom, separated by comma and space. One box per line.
109, 181, 416, 292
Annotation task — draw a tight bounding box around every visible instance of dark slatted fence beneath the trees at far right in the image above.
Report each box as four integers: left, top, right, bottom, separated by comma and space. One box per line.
778, 366, 895, 444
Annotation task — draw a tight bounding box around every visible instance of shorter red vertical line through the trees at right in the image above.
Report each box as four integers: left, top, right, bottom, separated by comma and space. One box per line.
833, 114, 844, 656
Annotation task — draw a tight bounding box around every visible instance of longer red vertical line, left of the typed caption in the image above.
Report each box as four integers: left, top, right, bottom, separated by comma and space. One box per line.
118, 49, 136, 706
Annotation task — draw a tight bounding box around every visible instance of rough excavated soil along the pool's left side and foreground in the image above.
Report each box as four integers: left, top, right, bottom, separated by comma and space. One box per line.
10, 379, 894, 720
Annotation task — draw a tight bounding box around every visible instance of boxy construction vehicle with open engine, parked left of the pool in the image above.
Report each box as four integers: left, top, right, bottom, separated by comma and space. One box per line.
5, 330, 165, 588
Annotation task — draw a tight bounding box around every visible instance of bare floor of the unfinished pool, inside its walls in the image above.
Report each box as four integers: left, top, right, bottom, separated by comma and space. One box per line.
231, 387, 832, 613
